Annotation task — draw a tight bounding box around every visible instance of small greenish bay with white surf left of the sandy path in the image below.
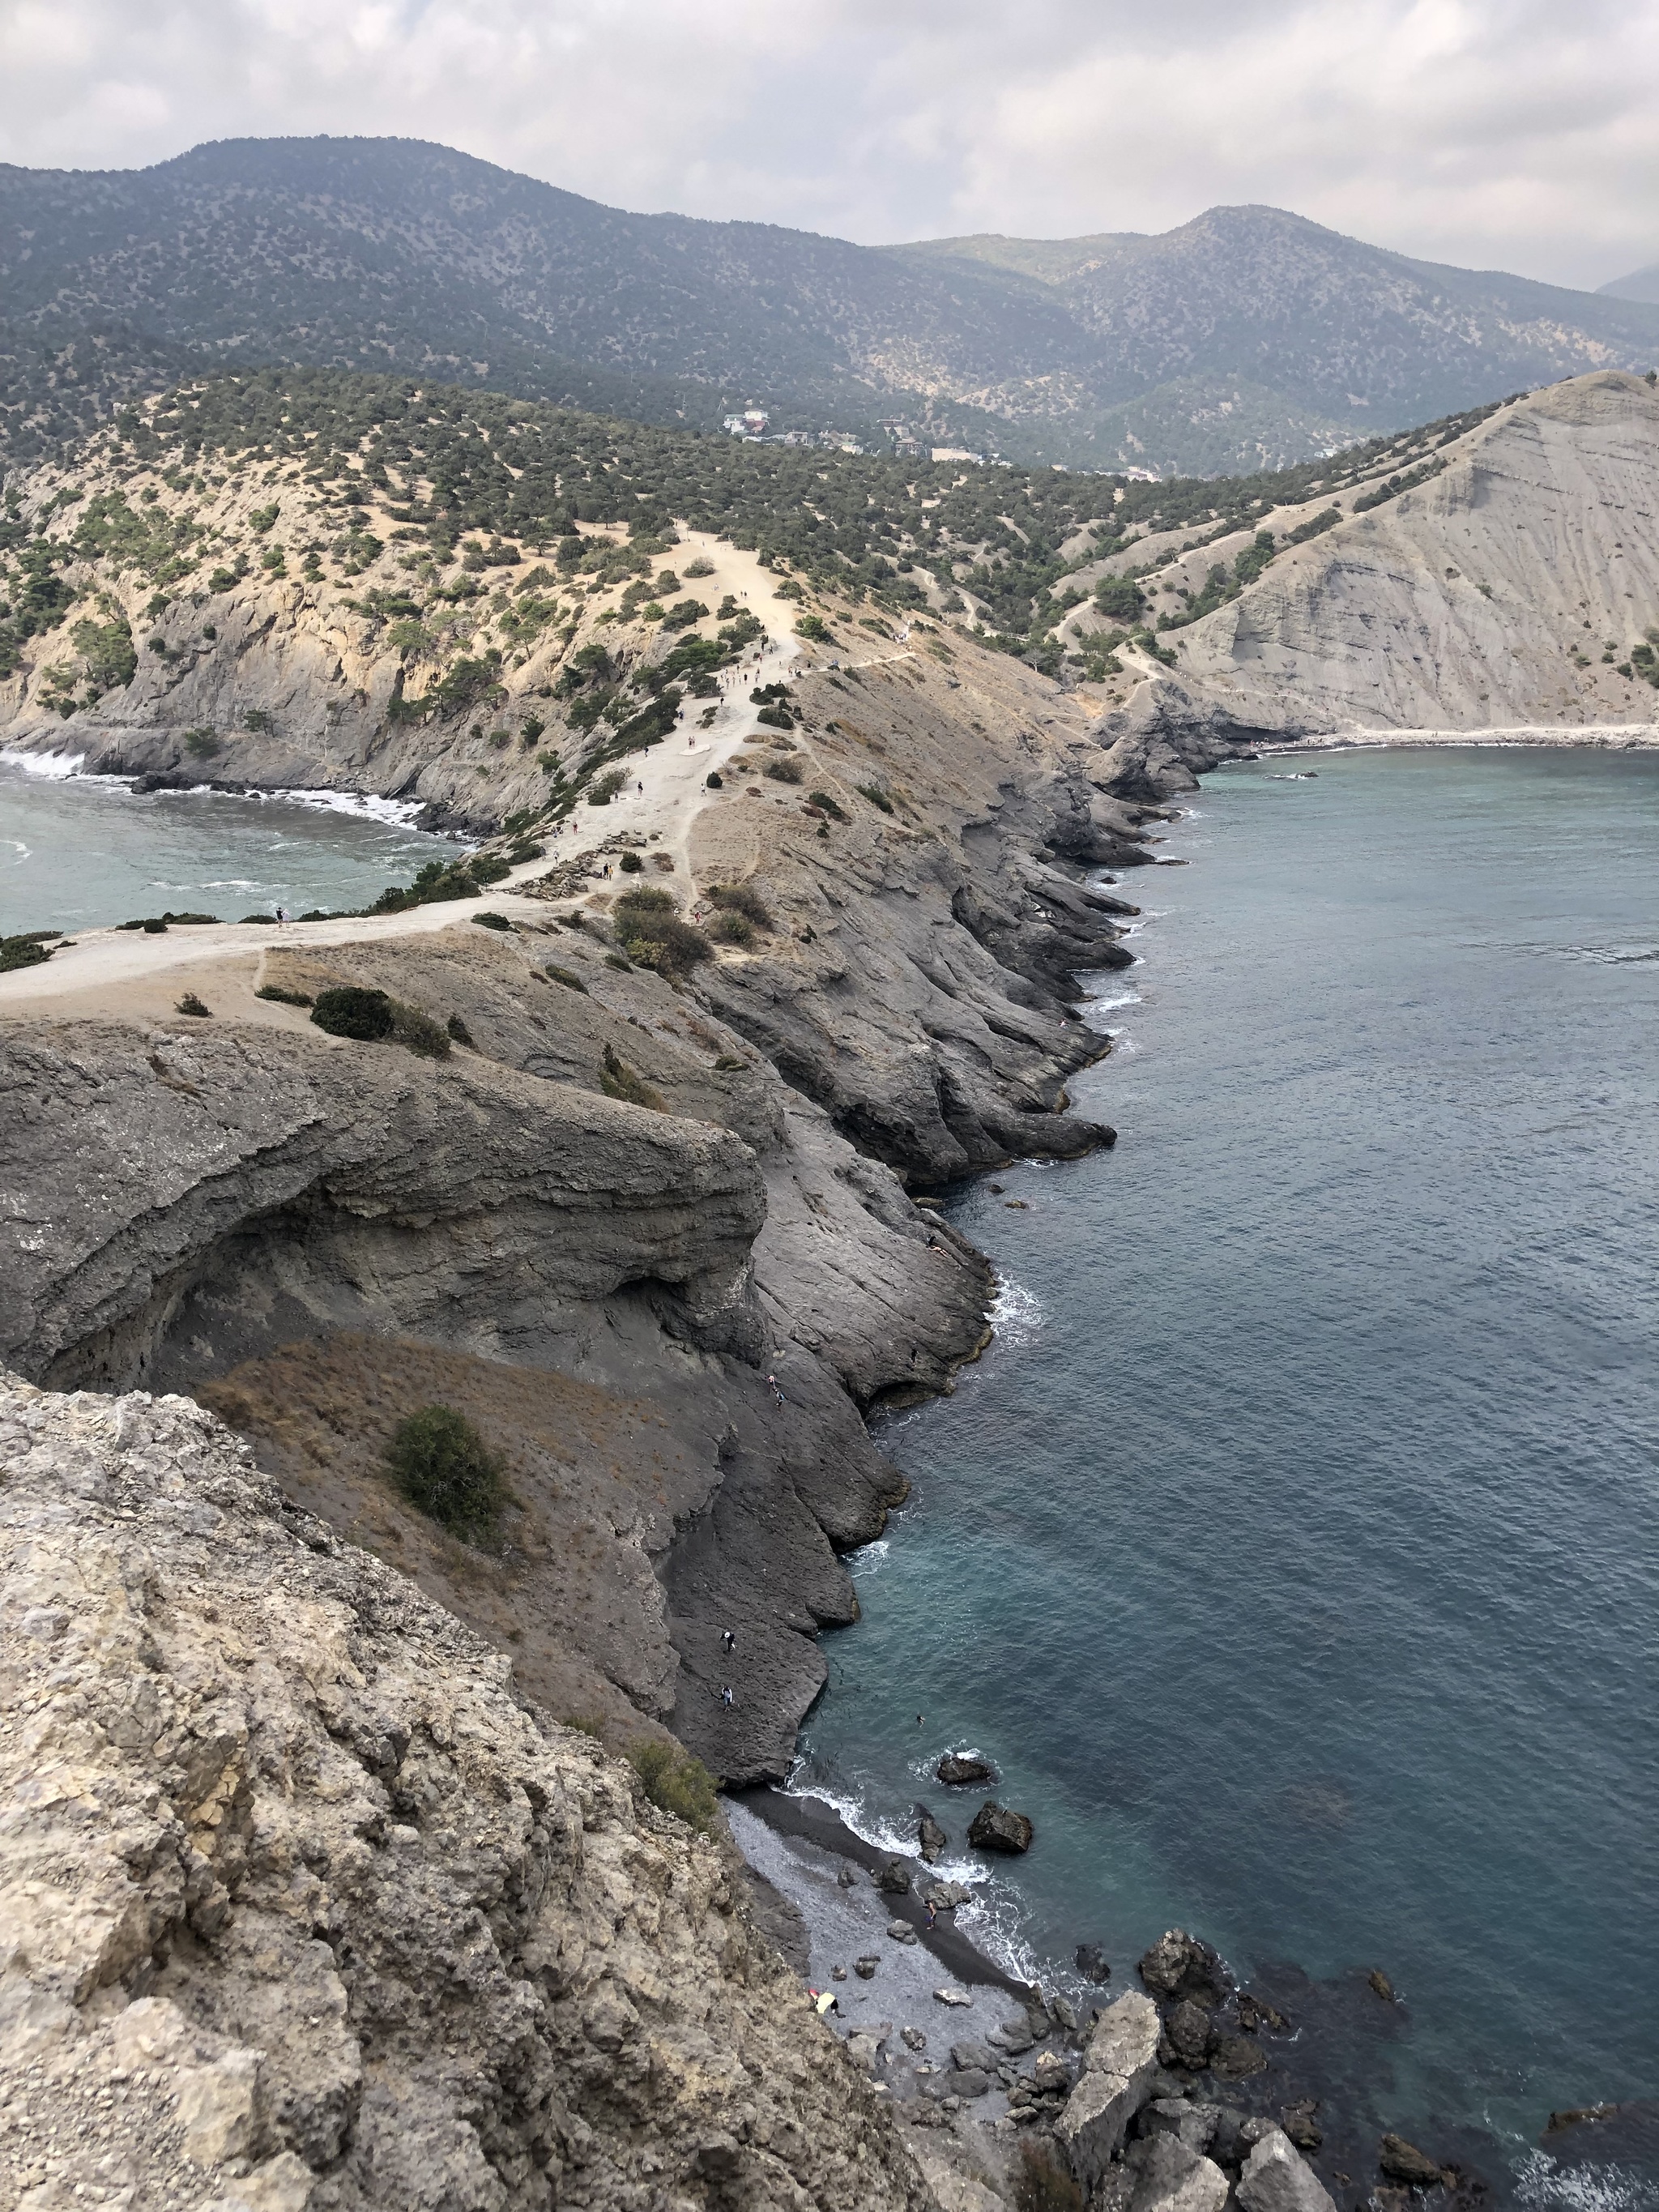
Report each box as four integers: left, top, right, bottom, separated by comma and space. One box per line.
0, 754, 460, 936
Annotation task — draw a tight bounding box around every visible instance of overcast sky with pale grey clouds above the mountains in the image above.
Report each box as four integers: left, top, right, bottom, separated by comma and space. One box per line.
0, 0, 1659, 285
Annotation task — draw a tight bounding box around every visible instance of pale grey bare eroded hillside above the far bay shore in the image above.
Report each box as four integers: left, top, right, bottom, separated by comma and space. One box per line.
1092, 372, 1659, 790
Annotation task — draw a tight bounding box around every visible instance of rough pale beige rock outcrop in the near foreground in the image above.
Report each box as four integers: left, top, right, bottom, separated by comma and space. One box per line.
0, 1378, 927, 2212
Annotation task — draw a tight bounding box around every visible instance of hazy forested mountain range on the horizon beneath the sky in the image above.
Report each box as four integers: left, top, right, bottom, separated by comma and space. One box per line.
0, 139, 1659, 473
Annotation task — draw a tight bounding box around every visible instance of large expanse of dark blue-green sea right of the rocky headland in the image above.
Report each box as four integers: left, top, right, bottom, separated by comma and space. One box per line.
799, 752, 1659, 2203
